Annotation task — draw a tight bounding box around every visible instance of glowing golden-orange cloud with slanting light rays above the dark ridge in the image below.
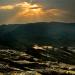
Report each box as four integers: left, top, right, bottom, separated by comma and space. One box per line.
0, 2, 68, 23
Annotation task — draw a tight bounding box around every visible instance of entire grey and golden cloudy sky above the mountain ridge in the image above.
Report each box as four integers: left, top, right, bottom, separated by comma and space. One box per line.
0, 0, 75, 24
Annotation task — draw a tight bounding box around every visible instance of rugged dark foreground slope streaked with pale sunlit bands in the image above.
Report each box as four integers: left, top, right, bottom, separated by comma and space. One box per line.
0, 46, 75, 75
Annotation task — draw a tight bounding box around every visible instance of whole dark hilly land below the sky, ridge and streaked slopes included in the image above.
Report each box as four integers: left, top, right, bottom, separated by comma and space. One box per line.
0, 22, 75, 75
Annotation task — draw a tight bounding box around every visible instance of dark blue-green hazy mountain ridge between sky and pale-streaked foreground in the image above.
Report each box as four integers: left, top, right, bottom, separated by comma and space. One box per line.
0, 22, 75, 48
